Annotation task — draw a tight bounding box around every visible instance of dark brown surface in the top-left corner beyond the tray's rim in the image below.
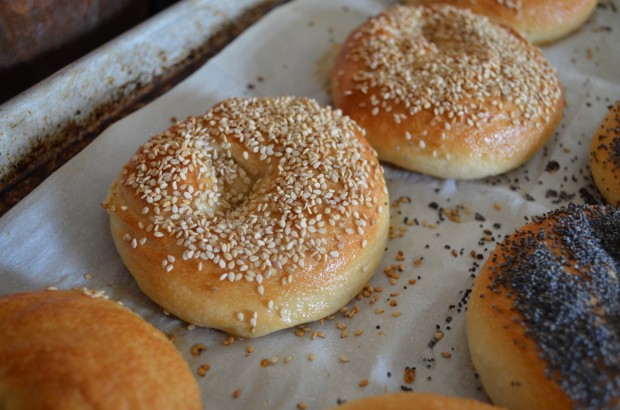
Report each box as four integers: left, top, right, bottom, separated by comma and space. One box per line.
0, 0, 151, 105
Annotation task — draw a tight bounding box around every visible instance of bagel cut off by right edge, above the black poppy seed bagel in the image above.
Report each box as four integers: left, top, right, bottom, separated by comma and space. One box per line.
590, 101, 620, 207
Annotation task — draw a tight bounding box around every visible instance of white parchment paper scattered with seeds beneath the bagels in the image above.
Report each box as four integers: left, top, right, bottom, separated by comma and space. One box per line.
0, 0, 620, 409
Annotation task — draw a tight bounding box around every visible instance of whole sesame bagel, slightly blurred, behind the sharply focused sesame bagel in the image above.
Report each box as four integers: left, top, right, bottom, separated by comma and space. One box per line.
332, 5, 564, 179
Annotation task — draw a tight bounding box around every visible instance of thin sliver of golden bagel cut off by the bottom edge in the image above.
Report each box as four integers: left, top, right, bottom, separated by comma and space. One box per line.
331, 393, 499, 410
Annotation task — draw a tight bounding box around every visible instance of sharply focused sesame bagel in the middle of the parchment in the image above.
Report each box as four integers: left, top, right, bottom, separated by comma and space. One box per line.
103, 97, 389, 337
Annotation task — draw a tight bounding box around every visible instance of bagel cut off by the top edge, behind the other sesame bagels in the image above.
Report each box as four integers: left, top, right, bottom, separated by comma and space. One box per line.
405, 0, 597, 45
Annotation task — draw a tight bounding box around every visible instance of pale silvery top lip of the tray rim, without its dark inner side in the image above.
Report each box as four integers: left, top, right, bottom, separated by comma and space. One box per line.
0, 0, 278, 188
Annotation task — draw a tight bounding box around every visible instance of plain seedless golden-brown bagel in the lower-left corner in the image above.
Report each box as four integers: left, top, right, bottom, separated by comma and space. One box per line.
0, 291, 202, 410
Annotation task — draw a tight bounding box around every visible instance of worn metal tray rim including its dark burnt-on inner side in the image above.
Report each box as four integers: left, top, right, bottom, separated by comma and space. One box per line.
0, 0, 286, 215
